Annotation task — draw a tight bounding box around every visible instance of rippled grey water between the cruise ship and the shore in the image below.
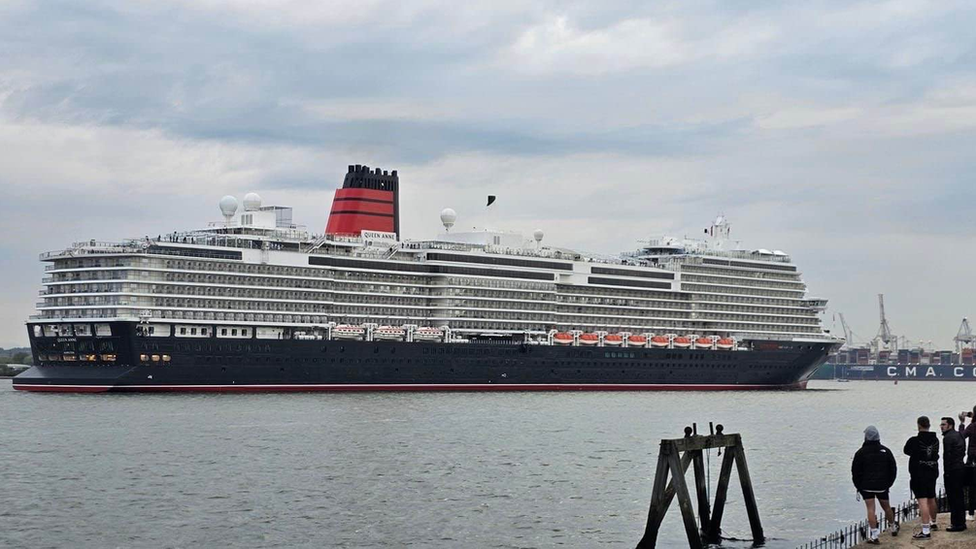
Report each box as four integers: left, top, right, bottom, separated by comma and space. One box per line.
0, 380, 976, 548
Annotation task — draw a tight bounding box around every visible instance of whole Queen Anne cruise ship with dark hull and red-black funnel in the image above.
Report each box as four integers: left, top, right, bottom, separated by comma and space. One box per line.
13, 165, 842, 392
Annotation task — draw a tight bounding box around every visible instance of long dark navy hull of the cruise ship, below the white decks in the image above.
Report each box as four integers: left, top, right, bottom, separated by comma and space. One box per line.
13, 322, 830, 391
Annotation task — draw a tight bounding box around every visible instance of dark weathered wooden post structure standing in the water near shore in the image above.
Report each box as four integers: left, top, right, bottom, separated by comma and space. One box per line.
637, 425, 766, 549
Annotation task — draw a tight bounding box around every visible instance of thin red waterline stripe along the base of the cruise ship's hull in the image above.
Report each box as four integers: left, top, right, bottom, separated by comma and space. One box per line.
14, 381, 807, 393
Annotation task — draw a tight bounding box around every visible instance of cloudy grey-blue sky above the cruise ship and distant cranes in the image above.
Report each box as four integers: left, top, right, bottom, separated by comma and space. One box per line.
0, 0, 976, 347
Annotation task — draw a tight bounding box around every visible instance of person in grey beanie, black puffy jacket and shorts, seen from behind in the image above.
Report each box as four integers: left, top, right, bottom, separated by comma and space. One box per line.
851, 425, 898, 544
